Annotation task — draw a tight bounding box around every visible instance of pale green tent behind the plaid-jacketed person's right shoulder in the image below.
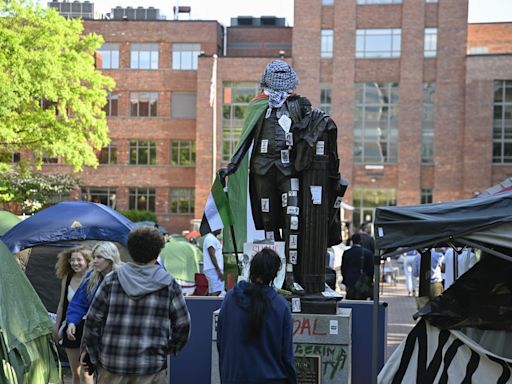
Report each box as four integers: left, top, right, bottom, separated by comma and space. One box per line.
160, 238, 203, 282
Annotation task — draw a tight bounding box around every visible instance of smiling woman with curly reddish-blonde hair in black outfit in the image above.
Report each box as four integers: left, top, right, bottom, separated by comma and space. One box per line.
55, 246, 92, 384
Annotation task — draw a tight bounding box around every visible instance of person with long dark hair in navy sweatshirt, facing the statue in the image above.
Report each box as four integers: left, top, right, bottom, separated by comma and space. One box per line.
217, 248, 297, 384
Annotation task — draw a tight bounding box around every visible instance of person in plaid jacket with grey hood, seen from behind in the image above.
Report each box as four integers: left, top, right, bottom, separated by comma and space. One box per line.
81, 227, 190, 384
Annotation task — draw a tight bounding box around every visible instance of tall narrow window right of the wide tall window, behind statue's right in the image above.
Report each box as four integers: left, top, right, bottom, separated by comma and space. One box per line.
421, 83, 436, 164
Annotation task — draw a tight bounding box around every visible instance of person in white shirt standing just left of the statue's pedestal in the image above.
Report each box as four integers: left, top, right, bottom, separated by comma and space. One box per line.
203, 229, 224, 296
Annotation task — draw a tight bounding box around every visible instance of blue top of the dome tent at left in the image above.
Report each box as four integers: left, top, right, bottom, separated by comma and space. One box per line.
2, 201, 133, 253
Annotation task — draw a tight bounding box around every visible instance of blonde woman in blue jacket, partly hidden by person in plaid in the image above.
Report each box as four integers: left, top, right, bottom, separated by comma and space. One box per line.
62, 241, 121, 384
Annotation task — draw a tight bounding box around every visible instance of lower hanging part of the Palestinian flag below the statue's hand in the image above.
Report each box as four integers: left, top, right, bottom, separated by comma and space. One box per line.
199, 173, 233, 236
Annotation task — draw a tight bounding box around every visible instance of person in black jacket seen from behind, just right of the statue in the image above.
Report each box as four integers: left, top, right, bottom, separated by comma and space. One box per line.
341, 233, 373, 300
